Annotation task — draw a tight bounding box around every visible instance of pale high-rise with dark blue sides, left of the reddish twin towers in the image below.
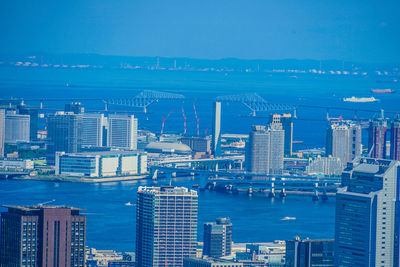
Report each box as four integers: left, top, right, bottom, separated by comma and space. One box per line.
326, 121, 362, 167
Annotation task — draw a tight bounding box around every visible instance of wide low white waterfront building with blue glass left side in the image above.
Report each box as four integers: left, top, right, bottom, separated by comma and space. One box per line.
55, 151, 147, 178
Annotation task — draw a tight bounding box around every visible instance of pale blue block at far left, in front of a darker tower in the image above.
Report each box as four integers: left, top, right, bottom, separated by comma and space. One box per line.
5, 111, 30, 144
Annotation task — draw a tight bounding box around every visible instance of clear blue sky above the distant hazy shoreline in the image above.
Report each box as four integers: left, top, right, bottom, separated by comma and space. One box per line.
0, 0, 400, 63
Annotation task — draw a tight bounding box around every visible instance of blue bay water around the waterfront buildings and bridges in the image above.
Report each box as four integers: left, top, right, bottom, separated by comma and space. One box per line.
0, 67, 400, 251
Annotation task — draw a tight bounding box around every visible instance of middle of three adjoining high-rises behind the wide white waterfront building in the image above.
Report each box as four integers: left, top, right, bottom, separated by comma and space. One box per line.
82, 113, 105, 147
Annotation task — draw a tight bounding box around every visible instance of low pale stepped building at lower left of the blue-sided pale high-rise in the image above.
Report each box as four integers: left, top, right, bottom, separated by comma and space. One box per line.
306, 156, 343, 176
